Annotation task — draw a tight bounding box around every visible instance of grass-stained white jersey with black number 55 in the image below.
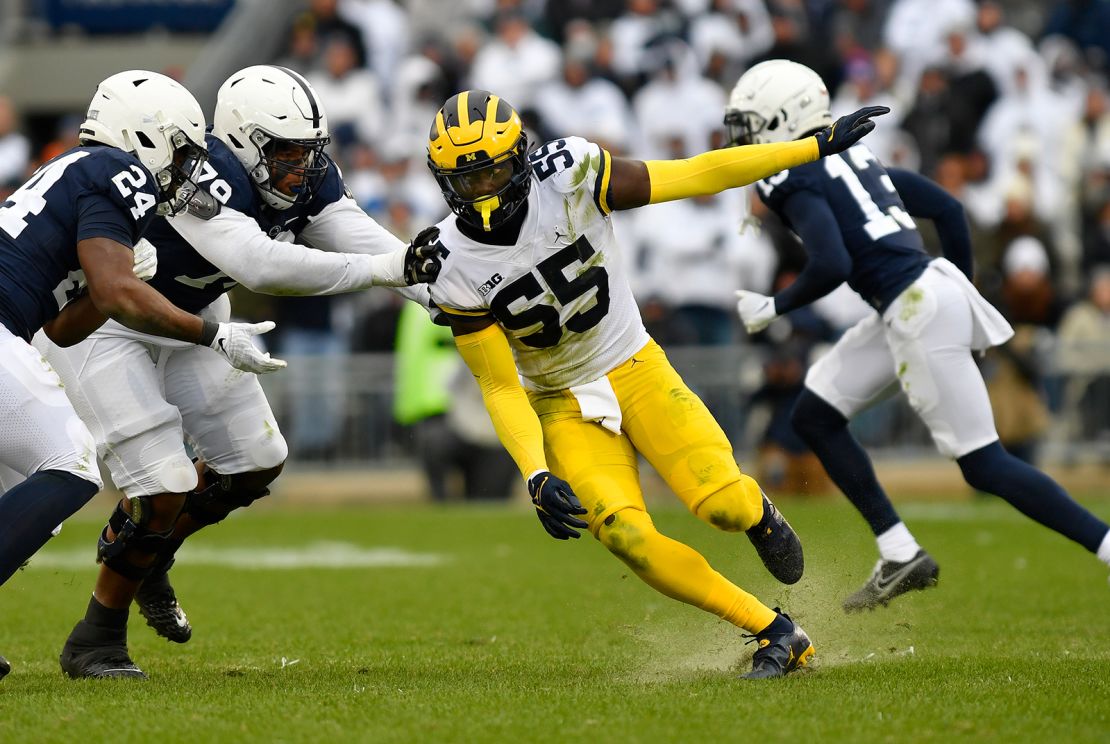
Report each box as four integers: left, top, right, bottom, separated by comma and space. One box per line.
428, 137, 648, 391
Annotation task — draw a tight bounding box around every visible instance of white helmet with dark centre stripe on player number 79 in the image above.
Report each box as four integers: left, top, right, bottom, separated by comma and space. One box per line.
212, 64, 331, 209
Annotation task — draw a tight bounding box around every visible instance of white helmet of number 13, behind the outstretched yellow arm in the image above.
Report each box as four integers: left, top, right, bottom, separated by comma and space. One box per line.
725, 60, 833, 144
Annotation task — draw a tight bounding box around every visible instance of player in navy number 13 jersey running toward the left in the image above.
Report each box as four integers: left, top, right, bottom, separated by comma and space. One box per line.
725, 60, 1110, 611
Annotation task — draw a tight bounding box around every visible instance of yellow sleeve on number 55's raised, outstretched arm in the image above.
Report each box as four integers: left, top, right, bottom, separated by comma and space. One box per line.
644, 137, 819, 204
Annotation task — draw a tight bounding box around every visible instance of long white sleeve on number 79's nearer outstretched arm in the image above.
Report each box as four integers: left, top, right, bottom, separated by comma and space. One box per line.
170, 208, 404, 294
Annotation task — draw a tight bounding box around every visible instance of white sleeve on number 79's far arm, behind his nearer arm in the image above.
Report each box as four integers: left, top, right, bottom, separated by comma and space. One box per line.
301, 198, 432, 308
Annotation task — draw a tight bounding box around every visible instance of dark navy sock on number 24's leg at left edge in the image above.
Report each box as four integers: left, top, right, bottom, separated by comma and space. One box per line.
0, 470, 97, 584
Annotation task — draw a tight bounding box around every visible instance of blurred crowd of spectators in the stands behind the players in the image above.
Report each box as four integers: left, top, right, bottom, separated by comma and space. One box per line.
0, 0, 1110, 497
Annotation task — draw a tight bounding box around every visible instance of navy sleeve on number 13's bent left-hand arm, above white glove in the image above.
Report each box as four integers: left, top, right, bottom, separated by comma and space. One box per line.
775, 191, 851, 314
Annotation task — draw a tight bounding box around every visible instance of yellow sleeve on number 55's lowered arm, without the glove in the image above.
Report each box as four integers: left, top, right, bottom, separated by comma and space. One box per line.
455, 324, 547, 477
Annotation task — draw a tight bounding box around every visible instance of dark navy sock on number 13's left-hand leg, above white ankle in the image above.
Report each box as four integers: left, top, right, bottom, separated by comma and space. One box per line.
790, 388, 901, 536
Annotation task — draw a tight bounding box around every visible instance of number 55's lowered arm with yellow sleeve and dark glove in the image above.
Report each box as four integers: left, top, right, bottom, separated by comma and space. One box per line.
448, 314, 587, 540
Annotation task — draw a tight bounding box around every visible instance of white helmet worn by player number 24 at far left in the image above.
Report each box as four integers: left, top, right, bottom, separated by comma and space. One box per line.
79, 70, 208, 215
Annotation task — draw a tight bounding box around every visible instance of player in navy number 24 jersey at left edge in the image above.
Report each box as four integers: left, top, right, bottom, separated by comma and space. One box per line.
0, 70, 286, 676
